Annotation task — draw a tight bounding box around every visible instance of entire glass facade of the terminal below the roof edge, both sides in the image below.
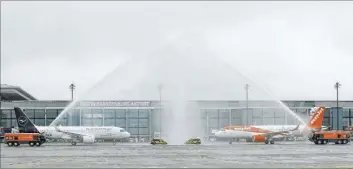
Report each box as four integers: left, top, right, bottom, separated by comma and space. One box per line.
0, 102, 353, 138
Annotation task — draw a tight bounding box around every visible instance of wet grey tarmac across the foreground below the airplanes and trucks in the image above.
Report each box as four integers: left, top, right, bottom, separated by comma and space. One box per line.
1, 141, 353, 168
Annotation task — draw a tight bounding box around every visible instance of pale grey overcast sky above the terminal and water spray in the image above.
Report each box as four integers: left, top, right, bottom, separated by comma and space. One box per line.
1, 1, 353, 100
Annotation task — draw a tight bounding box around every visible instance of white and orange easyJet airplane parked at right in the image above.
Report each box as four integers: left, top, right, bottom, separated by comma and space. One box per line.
215, 107, 327, 144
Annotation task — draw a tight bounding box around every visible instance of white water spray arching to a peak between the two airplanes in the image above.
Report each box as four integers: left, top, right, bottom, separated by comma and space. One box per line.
51, 32, 306, 144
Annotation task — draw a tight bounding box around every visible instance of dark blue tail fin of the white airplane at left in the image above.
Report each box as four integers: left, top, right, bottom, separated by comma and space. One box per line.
14, 107, 39, 133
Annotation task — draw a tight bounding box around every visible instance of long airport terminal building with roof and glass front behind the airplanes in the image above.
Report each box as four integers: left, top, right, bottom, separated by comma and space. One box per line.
0, 85, 353, 139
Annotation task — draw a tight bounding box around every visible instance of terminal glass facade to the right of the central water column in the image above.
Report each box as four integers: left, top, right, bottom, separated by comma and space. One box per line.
201, 108, 353, 135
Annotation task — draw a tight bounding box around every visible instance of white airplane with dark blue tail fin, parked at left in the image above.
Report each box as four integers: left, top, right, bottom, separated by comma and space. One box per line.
14, 107, 130, 145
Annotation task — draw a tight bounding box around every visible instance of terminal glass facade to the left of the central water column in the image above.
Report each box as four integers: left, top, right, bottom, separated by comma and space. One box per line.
0, 108, 150, 137
